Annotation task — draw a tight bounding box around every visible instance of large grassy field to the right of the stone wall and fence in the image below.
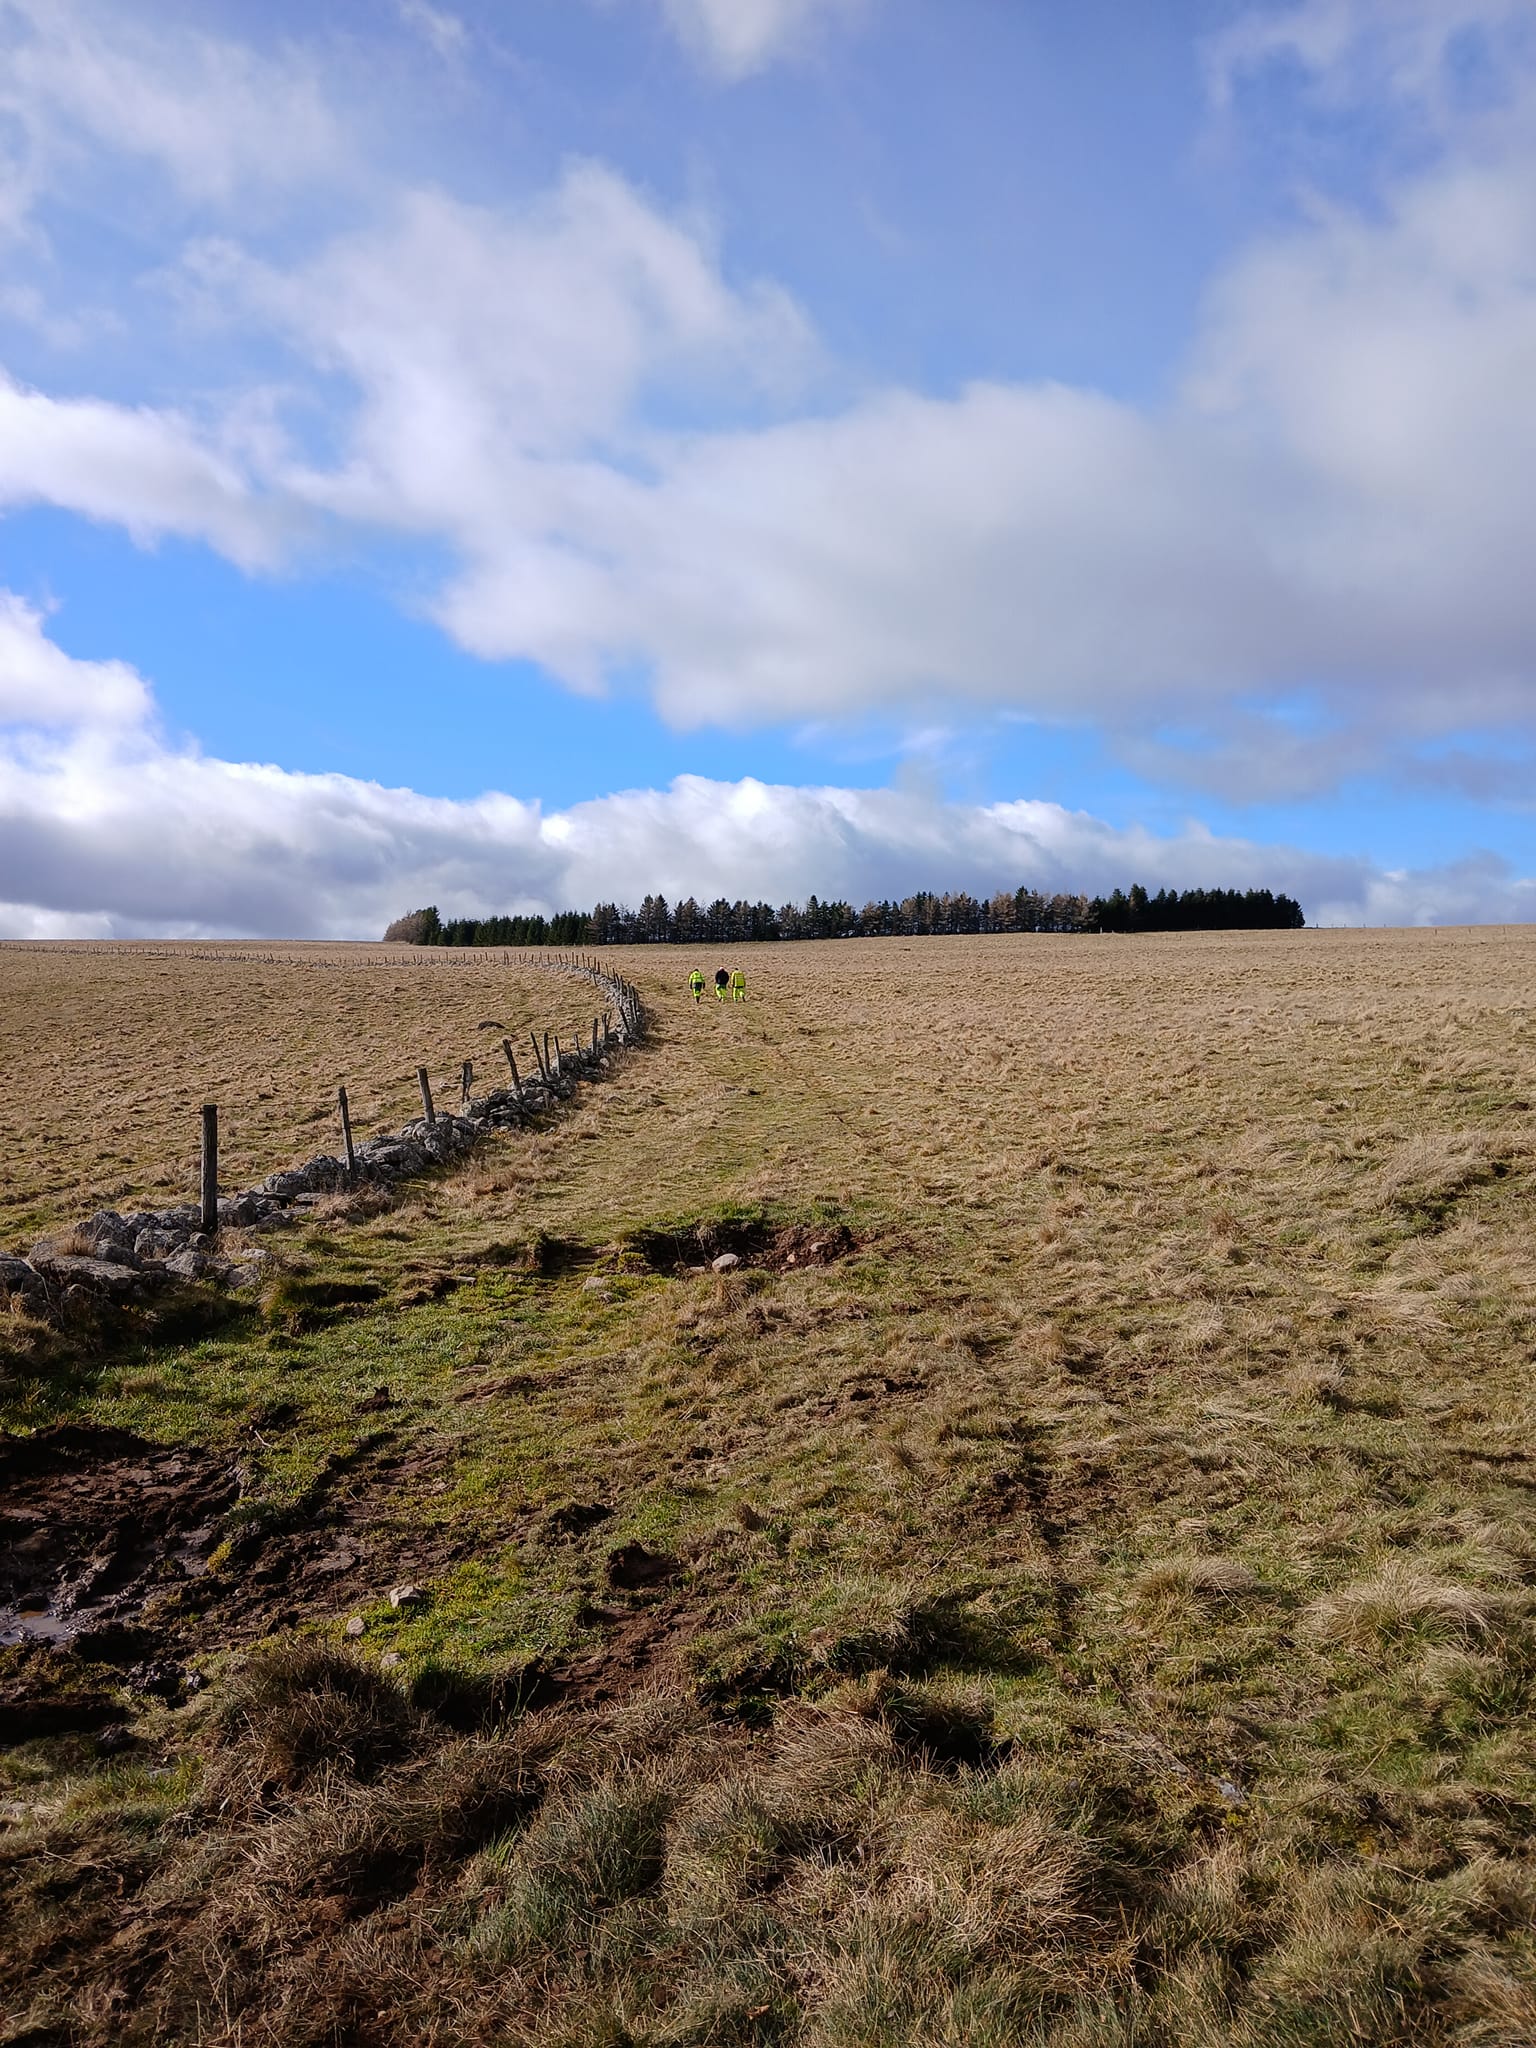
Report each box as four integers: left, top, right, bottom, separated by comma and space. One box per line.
0, 930, 1536, 2048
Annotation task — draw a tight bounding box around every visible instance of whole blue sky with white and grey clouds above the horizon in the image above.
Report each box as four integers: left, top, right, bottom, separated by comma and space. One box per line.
0, 0, 1536, 938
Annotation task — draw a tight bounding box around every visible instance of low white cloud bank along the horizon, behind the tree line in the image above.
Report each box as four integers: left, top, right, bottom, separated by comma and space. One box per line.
0, 596, 1536, 938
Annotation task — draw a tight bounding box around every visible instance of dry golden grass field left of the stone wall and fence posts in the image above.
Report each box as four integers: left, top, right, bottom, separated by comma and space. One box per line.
0, 944, 618, 1249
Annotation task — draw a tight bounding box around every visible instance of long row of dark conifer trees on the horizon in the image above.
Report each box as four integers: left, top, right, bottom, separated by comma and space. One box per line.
385, 883, 1307, 946
